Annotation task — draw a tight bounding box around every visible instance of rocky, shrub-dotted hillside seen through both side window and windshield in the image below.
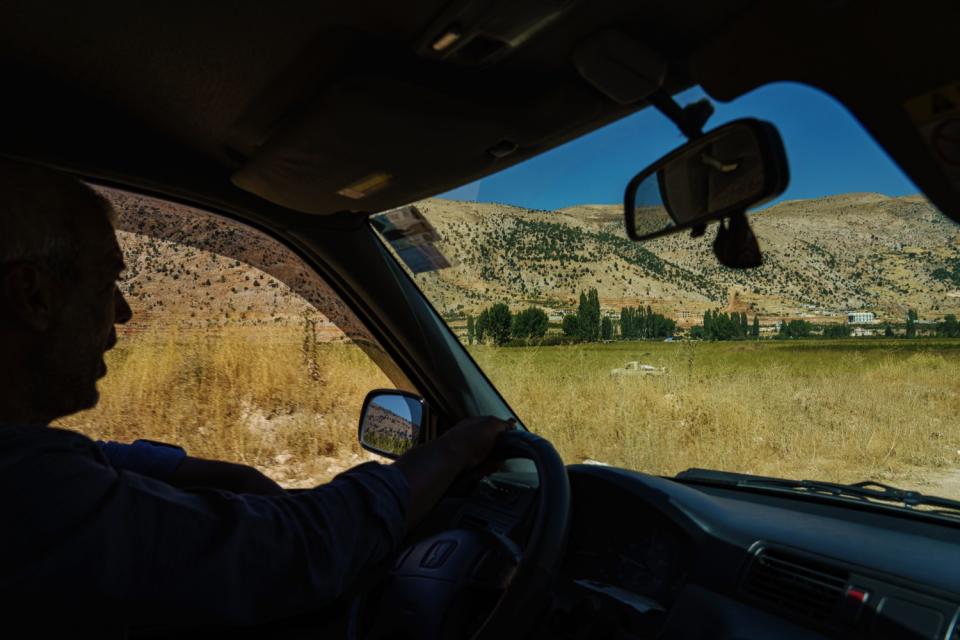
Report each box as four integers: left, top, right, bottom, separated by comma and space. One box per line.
90, 182, 960, 330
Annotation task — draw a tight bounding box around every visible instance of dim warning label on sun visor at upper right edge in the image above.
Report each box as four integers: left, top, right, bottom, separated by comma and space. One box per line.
904, 82, 960, 189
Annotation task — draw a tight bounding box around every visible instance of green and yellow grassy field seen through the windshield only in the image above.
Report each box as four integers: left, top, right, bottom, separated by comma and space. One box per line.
471, 339, 960, 497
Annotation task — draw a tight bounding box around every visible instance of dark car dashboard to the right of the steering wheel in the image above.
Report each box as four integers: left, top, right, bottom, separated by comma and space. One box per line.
544, 465, 960, 640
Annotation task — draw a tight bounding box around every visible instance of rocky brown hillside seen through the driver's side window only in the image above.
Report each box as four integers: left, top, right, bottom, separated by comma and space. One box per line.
101, 188, 354, 341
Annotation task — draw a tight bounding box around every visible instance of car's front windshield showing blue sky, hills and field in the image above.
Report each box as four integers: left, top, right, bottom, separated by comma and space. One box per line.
374, 84, 960, 497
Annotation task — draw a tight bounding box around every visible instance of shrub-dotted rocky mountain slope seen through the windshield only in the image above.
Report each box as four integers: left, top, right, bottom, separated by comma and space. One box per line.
408, 193, 960, 324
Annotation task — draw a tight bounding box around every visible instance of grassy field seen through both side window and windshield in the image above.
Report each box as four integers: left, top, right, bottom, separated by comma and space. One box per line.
62, 327, 960, 497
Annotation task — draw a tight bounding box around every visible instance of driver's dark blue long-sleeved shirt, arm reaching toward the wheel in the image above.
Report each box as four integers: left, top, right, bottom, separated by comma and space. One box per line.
0, 426, 409, 637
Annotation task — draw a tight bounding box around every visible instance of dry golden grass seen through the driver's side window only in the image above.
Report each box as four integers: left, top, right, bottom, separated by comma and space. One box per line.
60, 327, 393, 484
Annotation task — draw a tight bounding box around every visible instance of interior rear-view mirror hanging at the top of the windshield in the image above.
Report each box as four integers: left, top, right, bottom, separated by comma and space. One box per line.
624, 118, 790, 240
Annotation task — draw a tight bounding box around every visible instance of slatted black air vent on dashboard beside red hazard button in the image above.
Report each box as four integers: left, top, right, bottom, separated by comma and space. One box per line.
743, 549, 850, 624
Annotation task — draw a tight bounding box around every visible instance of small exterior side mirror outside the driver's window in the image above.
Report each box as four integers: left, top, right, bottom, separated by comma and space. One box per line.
357, 389, 426, 458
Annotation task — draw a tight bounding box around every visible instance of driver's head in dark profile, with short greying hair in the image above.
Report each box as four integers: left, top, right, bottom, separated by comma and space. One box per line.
0, 161, 131, 424
